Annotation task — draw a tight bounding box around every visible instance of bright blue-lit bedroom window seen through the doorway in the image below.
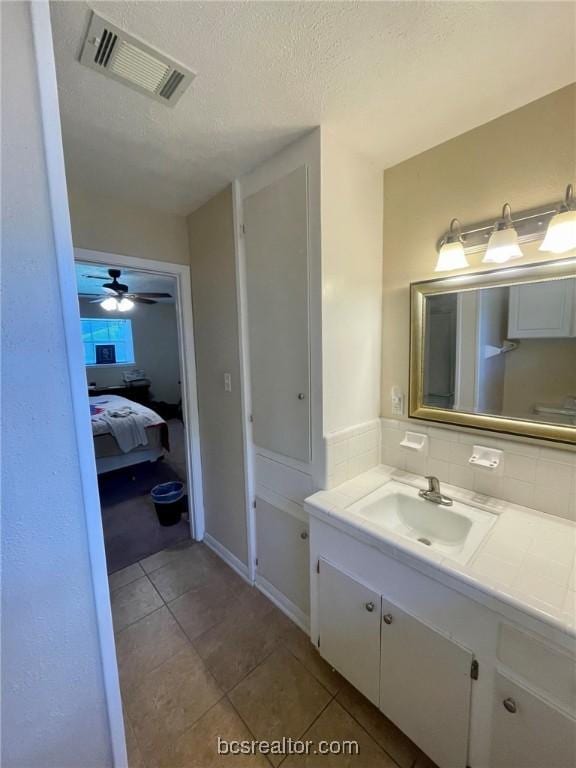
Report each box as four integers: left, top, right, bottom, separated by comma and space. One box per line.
80, 317, 135, 365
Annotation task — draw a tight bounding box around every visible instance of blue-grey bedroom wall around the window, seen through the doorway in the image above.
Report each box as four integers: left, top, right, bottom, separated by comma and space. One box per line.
80, 299, 180, 403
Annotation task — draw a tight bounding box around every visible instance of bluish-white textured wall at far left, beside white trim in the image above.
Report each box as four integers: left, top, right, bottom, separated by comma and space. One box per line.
1, 2, 112, 768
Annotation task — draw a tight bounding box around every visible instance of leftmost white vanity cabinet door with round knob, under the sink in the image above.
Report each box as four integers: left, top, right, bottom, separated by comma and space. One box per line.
318, 560, 380, 705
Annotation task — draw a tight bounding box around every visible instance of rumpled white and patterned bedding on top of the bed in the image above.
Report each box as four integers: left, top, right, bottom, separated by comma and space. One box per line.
89, 395, 164, 453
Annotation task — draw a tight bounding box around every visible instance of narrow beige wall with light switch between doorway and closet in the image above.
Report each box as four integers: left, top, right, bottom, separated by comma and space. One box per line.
188, 187, 247, 563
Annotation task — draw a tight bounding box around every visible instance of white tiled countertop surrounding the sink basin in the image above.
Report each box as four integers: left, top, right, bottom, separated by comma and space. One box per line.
306, 465, 576, 638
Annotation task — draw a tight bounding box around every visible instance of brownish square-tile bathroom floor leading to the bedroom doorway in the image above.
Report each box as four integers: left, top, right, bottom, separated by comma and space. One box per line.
110, 542, 434, 768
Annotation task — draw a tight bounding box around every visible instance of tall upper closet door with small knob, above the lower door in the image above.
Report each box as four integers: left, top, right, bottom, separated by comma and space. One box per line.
244, 166, 310, 462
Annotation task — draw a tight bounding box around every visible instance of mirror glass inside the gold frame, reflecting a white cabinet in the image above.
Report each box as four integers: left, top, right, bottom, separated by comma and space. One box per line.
423, 277, 576, 426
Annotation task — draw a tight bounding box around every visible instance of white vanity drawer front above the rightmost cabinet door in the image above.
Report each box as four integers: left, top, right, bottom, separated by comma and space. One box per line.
498, 623, 576, 714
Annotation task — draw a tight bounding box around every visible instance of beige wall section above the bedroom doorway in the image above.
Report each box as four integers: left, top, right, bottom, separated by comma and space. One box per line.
68, 186, 190, 264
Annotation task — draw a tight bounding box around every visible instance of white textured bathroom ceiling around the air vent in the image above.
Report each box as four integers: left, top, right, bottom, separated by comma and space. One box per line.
51, 0, 576, 213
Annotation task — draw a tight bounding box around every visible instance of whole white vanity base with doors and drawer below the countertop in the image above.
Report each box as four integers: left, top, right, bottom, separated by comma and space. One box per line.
308, 505, 576, 768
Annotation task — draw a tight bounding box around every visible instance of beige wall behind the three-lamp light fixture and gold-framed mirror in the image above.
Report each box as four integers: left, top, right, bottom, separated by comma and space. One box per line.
382, 85, 576, 416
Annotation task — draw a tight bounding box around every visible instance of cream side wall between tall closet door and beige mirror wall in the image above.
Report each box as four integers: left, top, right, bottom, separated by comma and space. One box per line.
321, 128, 383, 435
